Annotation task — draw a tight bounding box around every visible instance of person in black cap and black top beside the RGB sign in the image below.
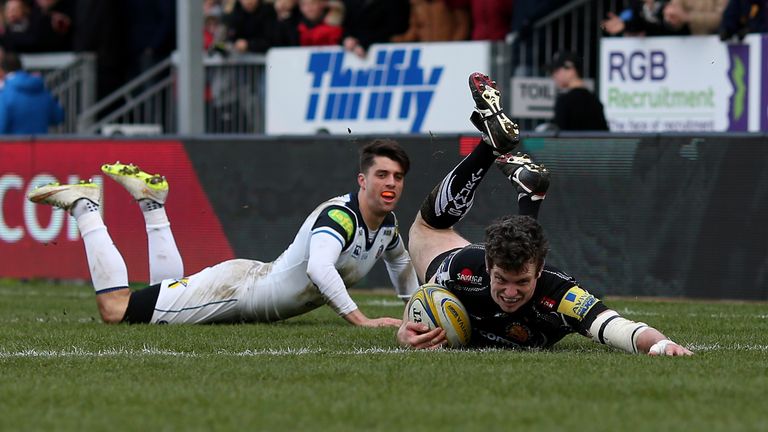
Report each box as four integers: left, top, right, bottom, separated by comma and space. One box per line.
549, 52, 609, 131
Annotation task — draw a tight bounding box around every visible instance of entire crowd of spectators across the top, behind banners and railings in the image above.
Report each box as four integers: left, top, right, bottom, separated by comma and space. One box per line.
0, 0, 768, 134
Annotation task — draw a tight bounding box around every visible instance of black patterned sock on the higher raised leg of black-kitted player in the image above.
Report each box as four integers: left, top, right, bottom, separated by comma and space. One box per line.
421, 141, 496, 229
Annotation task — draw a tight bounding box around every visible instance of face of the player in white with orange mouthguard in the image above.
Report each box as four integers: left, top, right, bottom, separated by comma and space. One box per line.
358, 156, 405, 215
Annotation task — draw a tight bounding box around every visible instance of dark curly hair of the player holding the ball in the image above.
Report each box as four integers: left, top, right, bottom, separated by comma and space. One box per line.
485, 215, 549, 272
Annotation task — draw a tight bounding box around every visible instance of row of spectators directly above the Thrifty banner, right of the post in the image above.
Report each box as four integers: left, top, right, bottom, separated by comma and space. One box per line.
204, 0, 514, 56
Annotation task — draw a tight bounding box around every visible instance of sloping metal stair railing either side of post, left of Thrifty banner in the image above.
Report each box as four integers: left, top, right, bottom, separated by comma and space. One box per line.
78, 55, 266, 134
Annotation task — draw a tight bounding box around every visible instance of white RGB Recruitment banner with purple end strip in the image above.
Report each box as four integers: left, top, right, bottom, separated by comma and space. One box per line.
600, 35, 768, 132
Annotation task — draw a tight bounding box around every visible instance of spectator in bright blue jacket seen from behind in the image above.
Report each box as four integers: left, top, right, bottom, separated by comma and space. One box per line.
0, 52, 64, 135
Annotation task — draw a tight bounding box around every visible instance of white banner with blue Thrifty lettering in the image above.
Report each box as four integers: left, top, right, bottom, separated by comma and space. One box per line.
266, 42, 490, 134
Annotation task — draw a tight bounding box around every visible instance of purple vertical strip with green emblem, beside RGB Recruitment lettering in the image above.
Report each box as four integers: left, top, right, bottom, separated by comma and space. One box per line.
728, 44, 749, 131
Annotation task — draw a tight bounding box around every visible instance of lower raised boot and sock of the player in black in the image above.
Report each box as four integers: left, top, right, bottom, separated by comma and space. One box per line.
496, 153, 549, 219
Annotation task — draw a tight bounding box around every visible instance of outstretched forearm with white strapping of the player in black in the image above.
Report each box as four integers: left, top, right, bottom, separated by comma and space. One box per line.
589, 309, 693, 356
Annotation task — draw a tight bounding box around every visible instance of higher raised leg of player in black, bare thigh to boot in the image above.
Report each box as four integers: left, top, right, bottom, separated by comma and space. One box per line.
408, 73, 519, 282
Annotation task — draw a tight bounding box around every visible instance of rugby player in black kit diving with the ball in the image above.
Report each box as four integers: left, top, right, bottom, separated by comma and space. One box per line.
397, 73, 693, 356
